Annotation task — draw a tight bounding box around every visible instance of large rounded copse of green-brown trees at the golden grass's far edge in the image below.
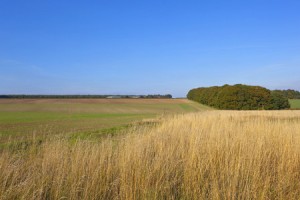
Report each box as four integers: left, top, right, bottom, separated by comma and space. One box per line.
187, 84, 290, 110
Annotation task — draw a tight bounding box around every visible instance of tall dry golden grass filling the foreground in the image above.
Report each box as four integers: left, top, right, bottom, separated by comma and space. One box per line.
0, 111, 300, 199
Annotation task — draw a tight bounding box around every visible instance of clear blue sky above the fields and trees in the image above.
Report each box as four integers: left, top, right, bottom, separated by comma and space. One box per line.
0, 0, 300, 97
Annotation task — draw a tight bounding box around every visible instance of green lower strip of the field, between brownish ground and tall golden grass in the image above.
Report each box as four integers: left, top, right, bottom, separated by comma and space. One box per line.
0, 112, 155, 138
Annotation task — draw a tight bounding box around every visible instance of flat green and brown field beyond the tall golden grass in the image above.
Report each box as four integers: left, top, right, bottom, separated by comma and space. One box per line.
0, 99, 209, 142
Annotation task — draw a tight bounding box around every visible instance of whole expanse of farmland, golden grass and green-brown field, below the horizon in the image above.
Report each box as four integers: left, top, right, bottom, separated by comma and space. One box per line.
0, 99, 300, 199
